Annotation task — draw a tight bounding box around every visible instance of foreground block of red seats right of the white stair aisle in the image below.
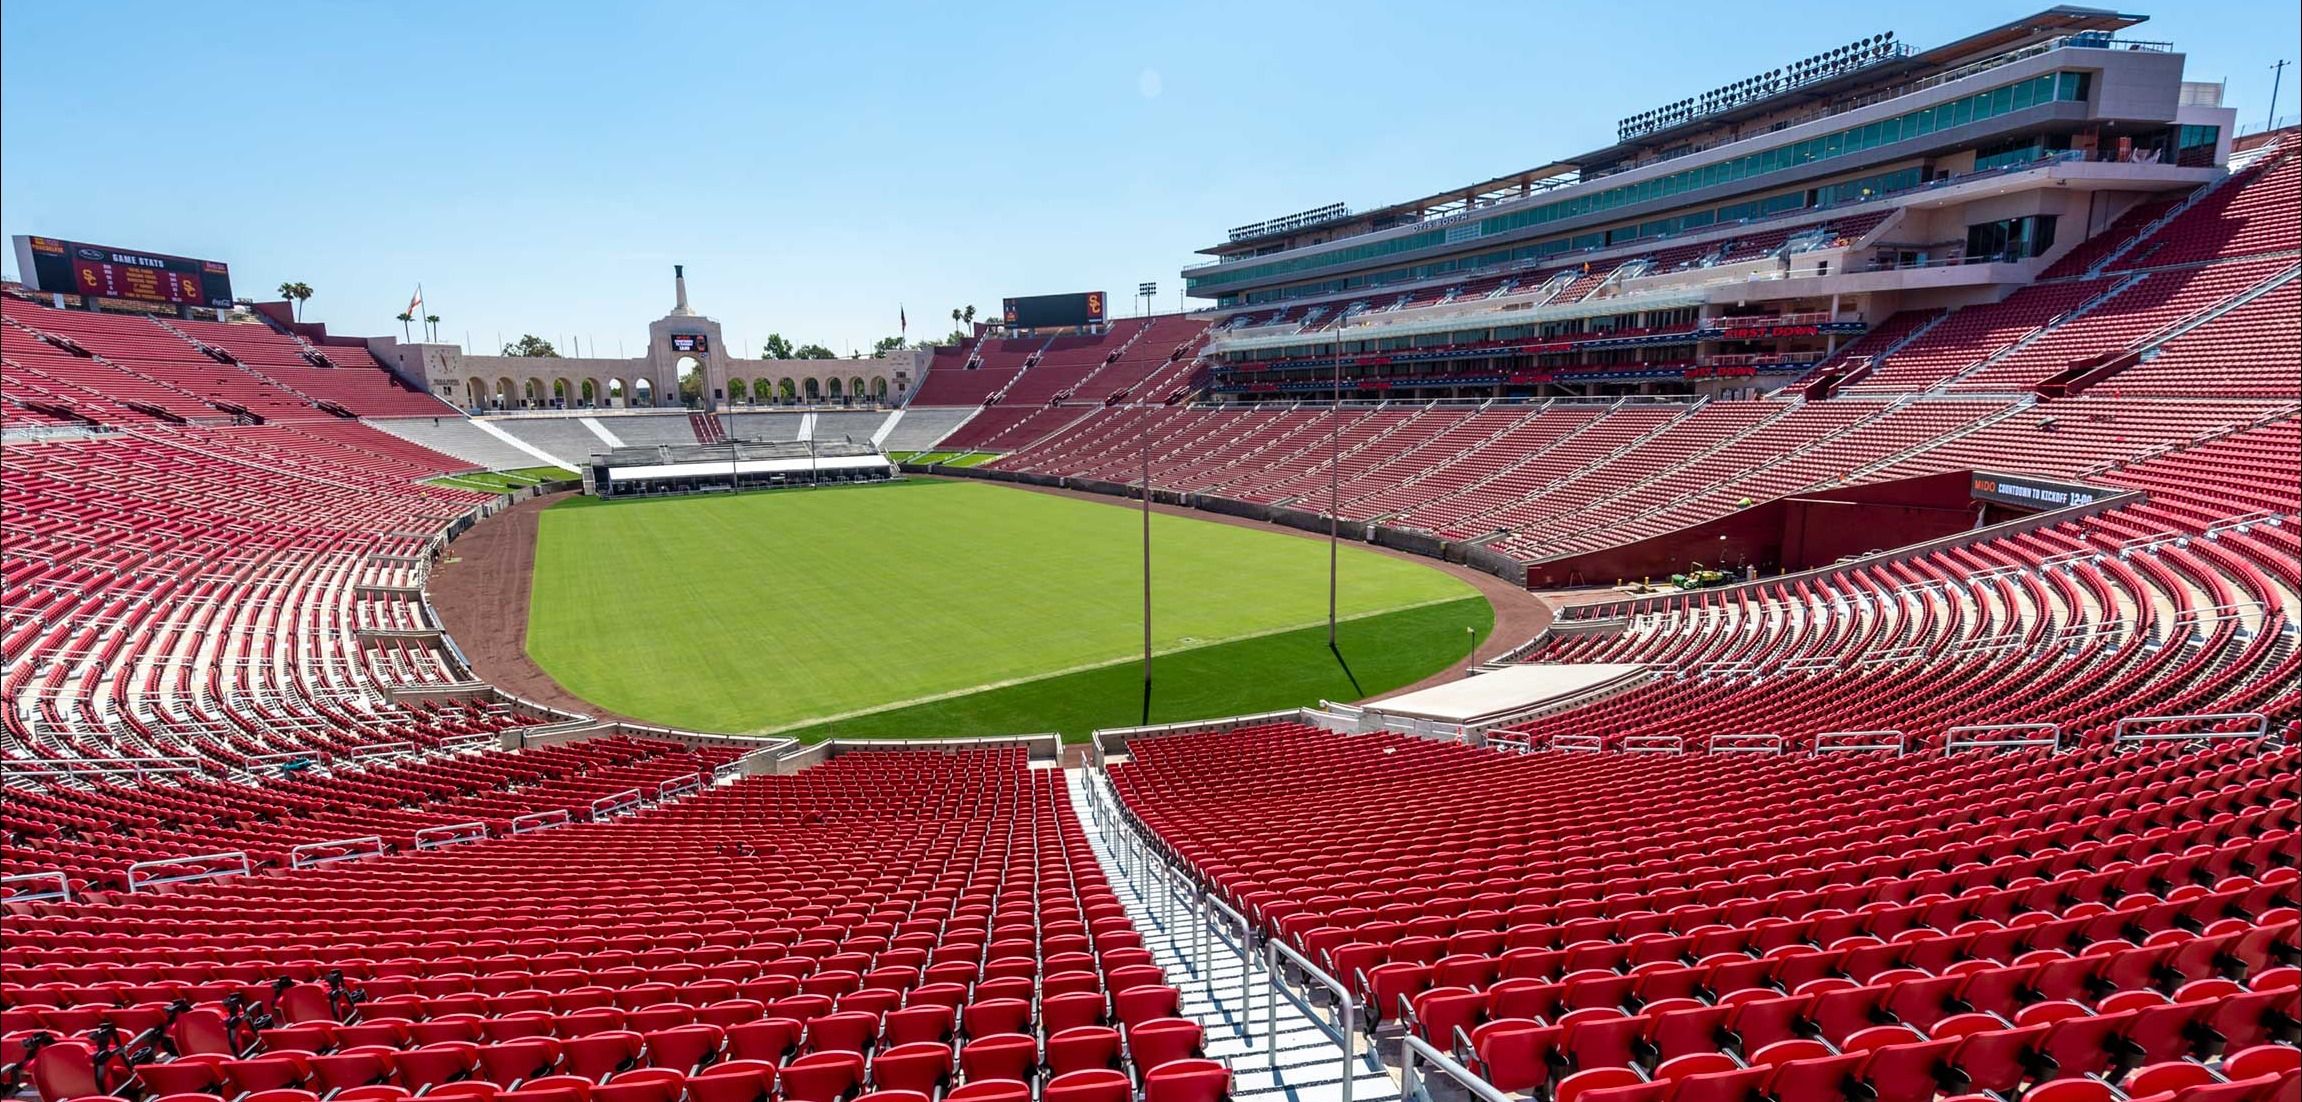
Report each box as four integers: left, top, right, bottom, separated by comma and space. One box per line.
1110, 725, 2302, 1102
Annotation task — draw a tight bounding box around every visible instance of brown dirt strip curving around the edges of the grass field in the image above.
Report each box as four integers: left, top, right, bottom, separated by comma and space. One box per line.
430, 476, 1552, 720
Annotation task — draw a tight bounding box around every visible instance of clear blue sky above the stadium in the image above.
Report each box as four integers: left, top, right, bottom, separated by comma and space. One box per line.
0, 0, 2302, 354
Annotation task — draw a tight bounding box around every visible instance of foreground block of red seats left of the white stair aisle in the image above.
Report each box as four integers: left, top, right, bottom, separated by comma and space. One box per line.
0, 750, 1229, 1102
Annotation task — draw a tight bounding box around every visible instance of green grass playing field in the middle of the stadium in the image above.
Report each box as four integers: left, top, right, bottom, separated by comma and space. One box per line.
527, 479, 1492, 739
